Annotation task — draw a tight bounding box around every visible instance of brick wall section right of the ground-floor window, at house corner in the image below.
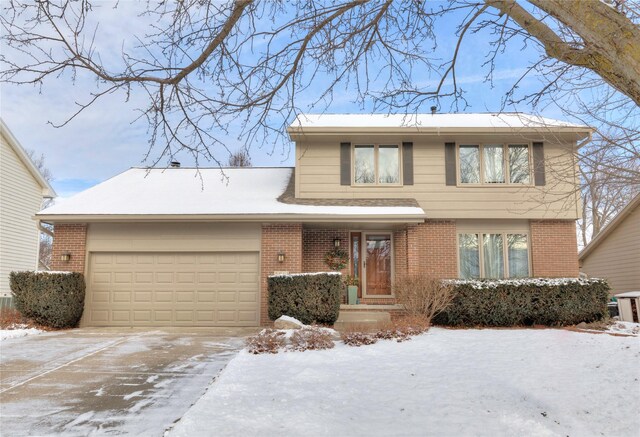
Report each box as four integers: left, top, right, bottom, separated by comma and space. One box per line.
530, 220, 578, 277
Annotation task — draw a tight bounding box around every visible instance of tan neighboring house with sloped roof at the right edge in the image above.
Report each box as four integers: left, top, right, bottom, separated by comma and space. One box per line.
580, 194, 640, 294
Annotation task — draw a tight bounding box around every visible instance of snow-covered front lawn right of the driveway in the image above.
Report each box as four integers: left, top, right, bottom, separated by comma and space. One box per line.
169, 328, 640, 437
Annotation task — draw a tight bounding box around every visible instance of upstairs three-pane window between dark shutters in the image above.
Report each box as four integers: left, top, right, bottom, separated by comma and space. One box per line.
458, 144, 531, 185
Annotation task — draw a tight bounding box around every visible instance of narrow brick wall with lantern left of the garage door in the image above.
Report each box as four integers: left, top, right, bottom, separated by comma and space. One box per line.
51, 223, 87, 273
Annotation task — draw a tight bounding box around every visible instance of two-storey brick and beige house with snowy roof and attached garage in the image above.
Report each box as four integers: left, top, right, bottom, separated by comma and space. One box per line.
38, 114, 592, 326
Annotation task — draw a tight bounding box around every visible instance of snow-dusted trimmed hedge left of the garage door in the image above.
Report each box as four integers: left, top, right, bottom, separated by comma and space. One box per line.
9, 272, 85, 328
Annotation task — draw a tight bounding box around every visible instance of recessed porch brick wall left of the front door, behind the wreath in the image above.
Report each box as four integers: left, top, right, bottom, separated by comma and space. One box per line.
302, 229, 350, 275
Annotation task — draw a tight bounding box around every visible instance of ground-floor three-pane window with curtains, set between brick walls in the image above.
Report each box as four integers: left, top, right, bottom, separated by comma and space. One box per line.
458, 233, 529, 279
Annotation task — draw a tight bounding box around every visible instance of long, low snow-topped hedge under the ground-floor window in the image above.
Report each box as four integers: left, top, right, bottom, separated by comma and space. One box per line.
434, 278, 609, 326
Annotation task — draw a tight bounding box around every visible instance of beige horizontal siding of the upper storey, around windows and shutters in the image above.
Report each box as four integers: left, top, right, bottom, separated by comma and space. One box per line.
296, 135, 580, 219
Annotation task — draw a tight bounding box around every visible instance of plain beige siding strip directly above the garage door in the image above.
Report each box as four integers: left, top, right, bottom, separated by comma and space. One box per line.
87, 223, 261, 252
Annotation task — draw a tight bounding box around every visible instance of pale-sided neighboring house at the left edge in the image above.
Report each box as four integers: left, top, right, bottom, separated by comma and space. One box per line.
0, 119, 56, 297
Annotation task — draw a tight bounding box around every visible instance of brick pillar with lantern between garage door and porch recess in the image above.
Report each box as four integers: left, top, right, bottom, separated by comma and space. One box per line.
260, 223, 302, 325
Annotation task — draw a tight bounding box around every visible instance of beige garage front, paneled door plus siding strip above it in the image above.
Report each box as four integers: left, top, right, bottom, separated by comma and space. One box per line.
81, 223, 260, 327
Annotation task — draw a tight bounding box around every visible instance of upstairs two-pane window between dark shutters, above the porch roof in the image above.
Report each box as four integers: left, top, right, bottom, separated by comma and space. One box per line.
353, 144, 400, 185
